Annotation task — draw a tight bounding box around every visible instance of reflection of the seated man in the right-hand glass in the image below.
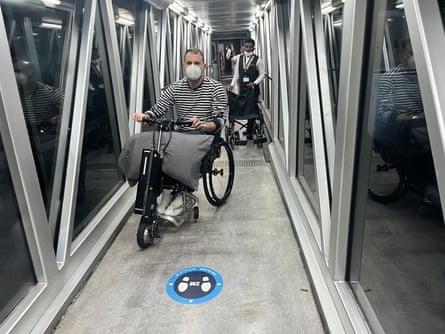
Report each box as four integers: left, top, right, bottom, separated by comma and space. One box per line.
374, 40, 440, 211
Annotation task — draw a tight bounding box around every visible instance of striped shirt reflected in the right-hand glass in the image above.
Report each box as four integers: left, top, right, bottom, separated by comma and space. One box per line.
377, 65, 423, 124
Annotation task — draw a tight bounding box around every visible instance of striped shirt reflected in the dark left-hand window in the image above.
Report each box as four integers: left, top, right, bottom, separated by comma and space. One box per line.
20, 82, 63, 124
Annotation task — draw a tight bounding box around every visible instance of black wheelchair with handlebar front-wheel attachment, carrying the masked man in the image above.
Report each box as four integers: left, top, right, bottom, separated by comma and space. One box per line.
134, 119, 235, 249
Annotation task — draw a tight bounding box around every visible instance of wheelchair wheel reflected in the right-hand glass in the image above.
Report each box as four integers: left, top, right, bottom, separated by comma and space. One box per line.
368, 147, 407, 204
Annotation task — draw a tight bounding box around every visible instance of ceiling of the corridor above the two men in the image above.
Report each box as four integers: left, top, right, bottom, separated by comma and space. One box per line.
175, 0, 267, 32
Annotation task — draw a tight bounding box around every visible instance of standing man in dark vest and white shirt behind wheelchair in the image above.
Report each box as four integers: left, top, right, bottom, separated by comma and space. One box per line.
229, 38, 265, 139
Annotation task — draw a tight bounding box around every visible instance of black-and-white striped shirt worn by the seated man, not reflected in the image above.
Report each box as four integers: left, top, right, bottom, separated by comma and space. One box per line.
147, 77, 228, 130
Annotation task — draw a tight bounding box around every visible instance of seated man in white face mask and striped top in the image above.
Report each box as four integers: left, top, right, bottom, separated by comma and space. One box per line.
133, 48, 228, 217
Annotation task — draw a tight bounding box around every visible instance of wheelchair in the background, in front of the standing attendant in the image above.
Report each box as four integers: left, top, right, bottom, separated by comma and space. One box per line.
226, 90, 267, 149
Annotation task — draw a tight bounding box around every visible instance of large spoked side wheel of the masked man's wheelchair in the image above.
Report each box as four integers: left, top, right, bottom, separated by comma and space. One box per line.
203, 140, 235, 206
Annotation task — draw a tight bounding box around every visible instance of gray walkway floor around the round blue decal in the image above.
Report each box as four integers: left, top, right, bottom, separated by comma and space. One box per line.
55, 143, 324, 334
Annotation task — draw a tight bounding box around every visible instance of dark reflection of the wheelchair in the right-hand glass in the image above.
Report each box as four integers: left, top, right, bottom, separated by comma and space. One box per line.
368, 120, 440, 216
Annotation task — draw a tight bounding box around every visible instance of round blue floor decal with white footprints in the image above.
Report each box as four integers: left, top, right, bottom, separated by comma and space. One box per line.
167, 267, 223, 304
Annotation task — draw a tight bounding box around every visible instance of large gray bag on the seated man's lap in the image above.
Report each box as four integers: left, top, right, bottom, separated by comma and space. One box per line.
118, 131, 213, 190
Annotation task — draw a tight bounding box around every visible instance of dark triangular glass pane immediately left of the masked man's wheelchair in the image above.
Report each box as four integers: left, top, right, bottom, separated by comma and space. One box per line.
73, 33, 124, 237
